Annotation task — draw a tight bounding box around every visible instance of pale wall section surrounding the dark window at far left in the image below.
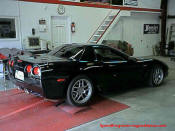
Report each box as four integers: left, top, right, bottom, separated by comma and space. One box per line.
0, 0, 21, 48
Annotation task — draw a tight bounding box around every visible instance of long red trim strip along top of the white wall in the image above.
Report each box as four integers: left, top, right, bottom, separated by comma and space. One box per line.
18, 0, 162, 12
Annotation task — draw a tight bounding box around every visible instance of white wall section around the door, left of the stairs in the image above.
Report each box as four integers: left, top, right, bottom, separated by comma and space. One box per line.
20, 2, 110, 48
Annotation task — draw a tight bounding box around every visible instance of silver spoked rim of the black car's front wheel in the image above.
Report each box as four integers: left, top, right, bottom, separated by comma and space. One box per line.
153, 68, 164, 85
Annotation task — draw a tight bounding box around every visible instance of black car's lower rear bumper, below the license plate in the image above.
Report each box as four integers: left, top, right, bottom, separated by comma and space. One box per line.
10, 76, 65, 99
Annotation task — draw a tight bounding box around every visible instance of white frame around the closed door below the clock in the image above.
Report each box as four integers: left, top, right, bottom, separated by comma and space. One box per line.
50, 16, 72, 48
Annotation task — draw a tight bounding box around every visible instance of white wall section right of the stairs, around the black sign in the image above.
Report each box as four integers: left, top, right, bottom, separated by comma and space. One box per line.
105, 13, 160, 56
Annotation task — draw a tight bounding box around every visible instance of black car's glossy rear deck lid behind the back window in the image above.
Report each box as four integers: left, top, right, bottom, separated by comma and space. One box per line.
18, 55, 71, 64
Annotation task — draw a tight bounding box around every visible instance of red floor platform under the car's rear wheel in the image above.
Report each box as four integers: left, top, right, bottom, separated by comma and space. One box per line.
0, 88, 129, 131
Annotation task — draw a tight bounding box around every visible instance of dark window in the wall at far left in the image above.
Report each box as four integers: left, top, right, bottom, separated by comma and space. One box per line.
0, 18, 16, 39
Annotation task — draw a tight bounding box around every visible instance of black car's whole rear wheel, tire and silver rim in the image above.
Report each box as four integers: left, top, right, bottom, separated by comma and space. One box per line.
66, 75, 94, 106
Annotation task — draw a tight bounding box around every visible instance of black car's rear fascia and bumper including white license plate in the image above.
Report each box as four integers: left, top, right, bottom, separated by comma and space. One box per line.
7, 56, 66, 99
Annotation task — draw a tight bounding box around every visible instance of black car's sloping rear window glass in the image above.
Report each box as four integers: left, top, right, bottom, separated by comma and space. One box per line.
48, 45, 83, 59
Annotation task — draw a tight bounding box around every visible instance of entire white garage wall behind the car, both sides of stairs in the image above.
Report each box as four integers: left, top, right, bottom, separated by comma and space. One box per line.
0, 0, 160, 56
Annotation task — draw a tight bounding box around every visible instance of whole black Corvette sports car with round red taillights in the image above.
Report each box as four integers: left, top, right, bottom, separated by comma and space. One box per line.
8, 44, 168, 106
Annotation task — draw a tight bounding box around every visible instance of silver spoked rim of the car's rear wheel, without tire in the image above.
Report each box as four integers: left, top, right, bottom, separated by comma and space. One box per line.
71, 79, 92, 104
